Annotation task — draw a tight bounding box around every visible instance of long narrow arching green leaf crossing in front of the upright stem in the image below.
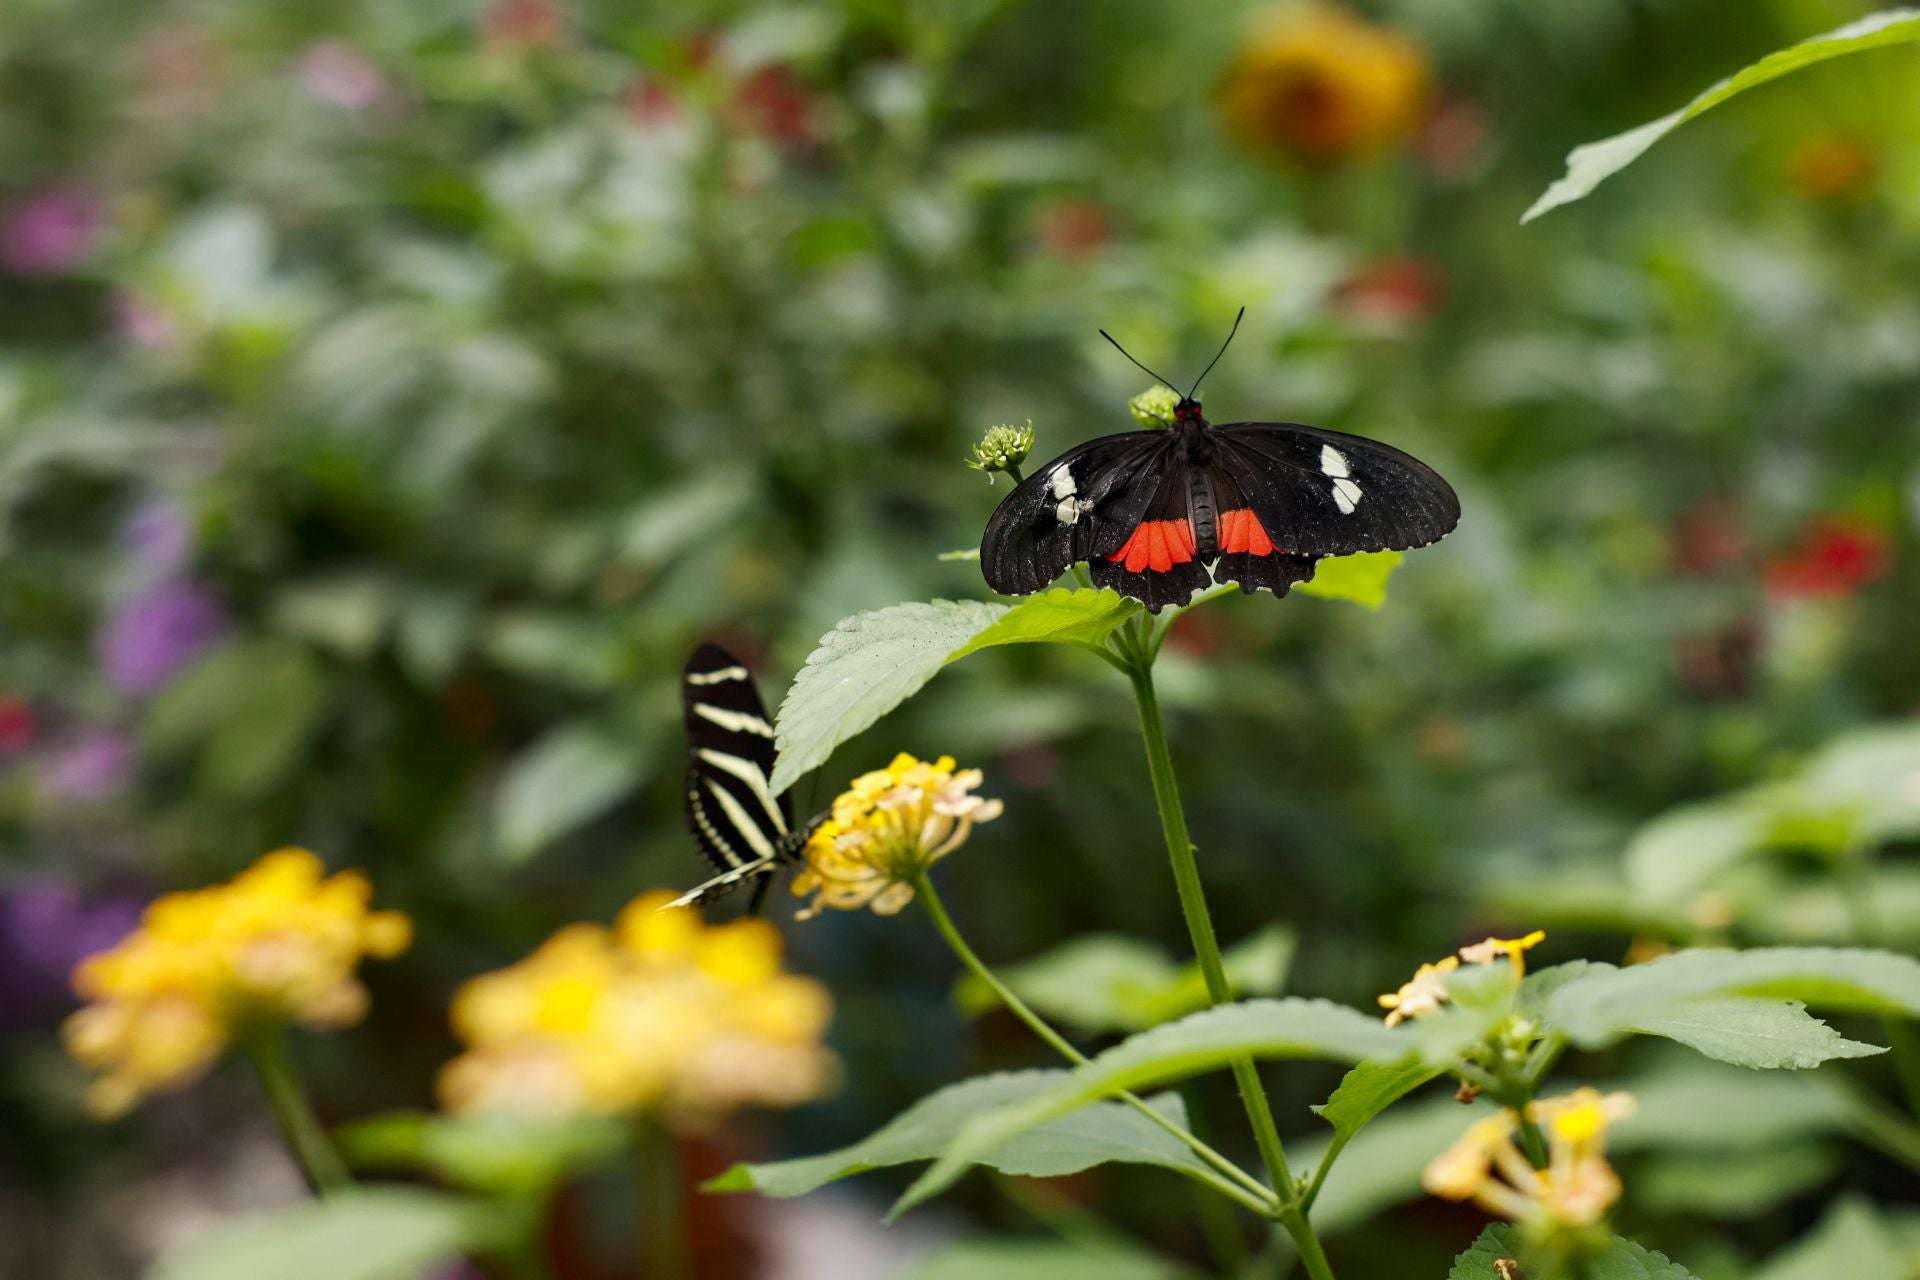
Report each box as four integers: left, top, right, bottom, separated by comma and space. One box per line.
891, 1000, 1411, 1217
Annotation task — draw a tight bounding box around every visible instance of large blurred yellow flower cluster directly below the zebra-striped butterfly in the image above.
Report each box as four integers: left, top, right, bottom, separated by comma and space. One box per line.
440, 890, 837, 1128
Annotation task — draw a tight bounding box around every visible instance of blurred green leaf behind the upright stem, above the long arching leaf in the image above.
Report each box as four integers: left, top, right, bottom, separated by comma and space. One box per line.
958, 925, 1294, 1034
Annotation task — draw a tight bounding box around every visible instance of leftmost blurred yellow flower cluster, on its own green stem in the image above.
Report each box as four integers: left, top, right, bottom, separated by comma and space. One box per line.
65, 848, 413, 1115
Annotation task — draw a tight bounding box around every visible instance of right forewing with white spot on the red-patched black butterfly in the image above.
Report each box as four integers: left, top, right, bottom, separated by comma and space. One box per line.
1212, 422, 1459, 557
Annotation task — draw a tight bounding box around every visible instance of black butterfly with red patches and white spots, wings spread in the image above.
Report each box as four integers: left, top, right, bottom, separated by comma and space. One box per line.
979, 309, 1459, 614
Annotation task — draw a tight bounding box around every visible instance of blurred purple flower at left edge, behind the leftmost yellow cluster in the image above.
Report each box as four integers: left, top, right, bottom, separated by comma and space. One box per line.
0, 875, 140, 1031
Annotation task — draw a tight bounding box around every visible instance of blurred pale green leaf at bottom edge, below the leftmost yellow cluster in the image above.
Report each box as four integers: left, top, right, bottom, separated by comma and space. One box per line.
152, 1186, 499, 1280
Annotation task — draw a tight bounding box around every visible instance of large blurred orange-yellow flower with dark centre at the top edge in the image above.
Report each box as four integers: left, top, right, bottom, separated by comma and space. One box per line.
1219, 4, 1427, 163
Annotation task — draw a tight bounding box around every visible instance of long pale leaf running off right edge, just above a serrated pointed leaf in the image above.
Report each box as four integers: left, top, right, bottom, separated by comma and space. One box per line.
1548, 946, 1920, 1048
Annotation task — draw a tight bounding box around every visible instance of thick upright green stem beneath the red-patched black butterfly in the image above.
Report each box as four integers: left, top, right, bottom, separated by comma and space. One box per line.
1123, 644, 1332, 1280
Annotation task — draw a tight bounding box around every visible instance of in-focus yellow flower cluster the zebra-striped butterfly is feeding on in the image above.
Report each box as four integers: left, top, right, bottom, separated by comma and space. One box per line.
793, 752, 1000, 919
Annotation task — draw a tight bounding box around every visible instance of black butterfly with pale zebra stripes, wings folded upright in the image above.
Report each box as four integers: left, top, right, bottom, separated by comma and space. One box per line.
672, 645, 824, 913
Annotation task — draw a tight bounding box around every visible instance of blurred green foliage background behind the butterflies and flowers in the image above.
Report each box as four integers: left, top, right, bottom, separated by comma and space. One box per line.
11, 0, 1920, 1276
